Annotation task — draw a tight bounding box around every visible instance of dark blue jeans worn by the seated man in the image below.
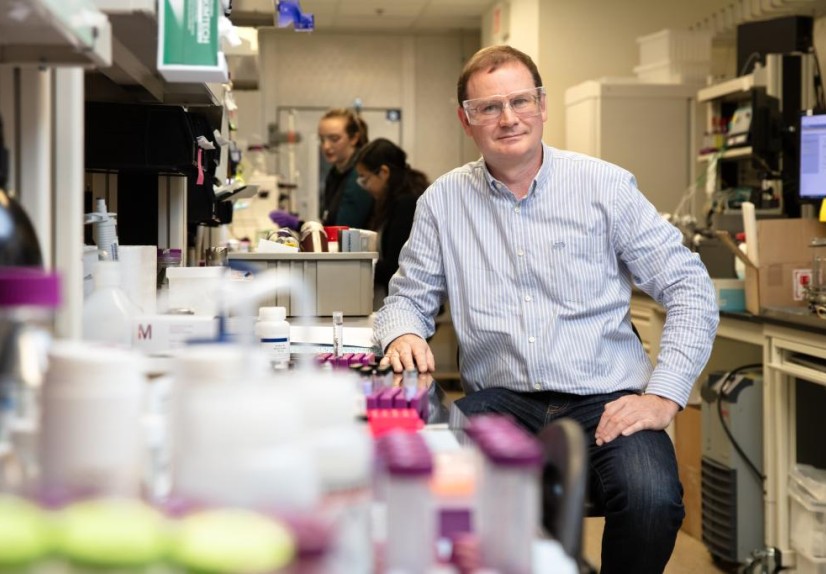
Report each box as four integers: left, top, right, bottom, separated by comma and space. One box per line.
456, 388, 685, 574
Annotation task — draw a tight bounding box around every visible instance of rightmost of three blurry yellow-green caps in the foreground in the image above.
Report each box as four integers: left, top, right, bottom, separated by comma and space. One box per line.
171, 508, 296, 574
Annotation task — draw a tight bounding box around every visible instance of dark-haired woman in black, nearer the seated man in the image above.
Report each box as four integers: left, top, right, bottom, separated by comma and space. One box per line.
355, 138, 430, 293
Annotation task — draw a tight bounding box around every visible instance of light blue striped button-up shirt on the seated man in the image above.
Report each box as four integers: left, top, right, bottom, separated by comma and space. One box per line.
374, 145, 719, 412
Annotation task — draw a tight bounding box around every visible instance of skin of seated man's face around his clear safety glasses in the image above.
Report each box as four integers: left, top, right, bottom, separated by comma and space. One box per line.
458, 62, 547, 163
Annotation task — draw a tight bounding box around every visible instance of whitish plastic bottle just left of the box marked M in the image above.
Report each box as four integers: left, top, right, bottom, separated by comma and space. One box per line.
83, 261, 138, 347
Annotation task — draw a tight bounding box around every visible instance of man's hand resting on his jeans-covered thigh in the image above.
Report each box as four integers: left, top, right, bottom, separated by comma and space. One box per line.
594, 395, 680, 446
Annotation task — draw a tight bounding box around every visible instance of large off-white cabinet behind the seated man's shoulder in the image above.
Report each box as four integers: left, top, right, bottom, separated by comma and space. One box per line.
565, 78, 697, 216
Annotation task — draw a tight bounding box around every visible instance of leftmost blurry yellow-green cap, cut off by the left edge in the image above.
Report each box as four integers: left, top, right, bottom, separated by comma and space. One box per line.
0, 495, 54, 574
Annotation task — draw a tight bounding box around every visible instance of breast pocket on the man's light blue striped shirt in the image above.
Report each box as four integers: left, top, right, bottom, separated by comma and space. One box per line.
549, 235, 609, 303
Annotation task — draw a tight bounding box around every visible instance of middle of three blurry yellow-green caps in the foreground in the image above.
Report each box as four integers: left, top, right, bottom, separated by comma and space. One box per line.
55, 498, 171, 574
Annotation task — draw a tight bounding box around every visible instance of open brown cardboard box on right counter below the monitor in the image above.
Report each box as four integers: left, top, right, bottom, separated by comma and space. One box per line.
717, 219, 826, 315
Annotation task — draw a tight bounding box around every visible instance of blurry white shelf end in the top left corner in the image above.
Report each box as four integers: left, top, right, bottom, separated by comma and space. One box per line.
0, 0, 112, 67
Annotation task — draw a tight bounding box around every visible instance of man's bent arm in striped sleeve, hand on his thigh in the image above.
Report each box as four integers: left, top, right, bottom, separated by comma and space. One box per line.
596, 177, 719, 445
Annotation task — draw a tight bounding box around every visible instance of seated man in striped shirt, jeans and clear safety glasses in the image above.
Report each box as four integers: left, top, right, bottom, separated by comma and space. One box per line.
374, 46, 718, 574
